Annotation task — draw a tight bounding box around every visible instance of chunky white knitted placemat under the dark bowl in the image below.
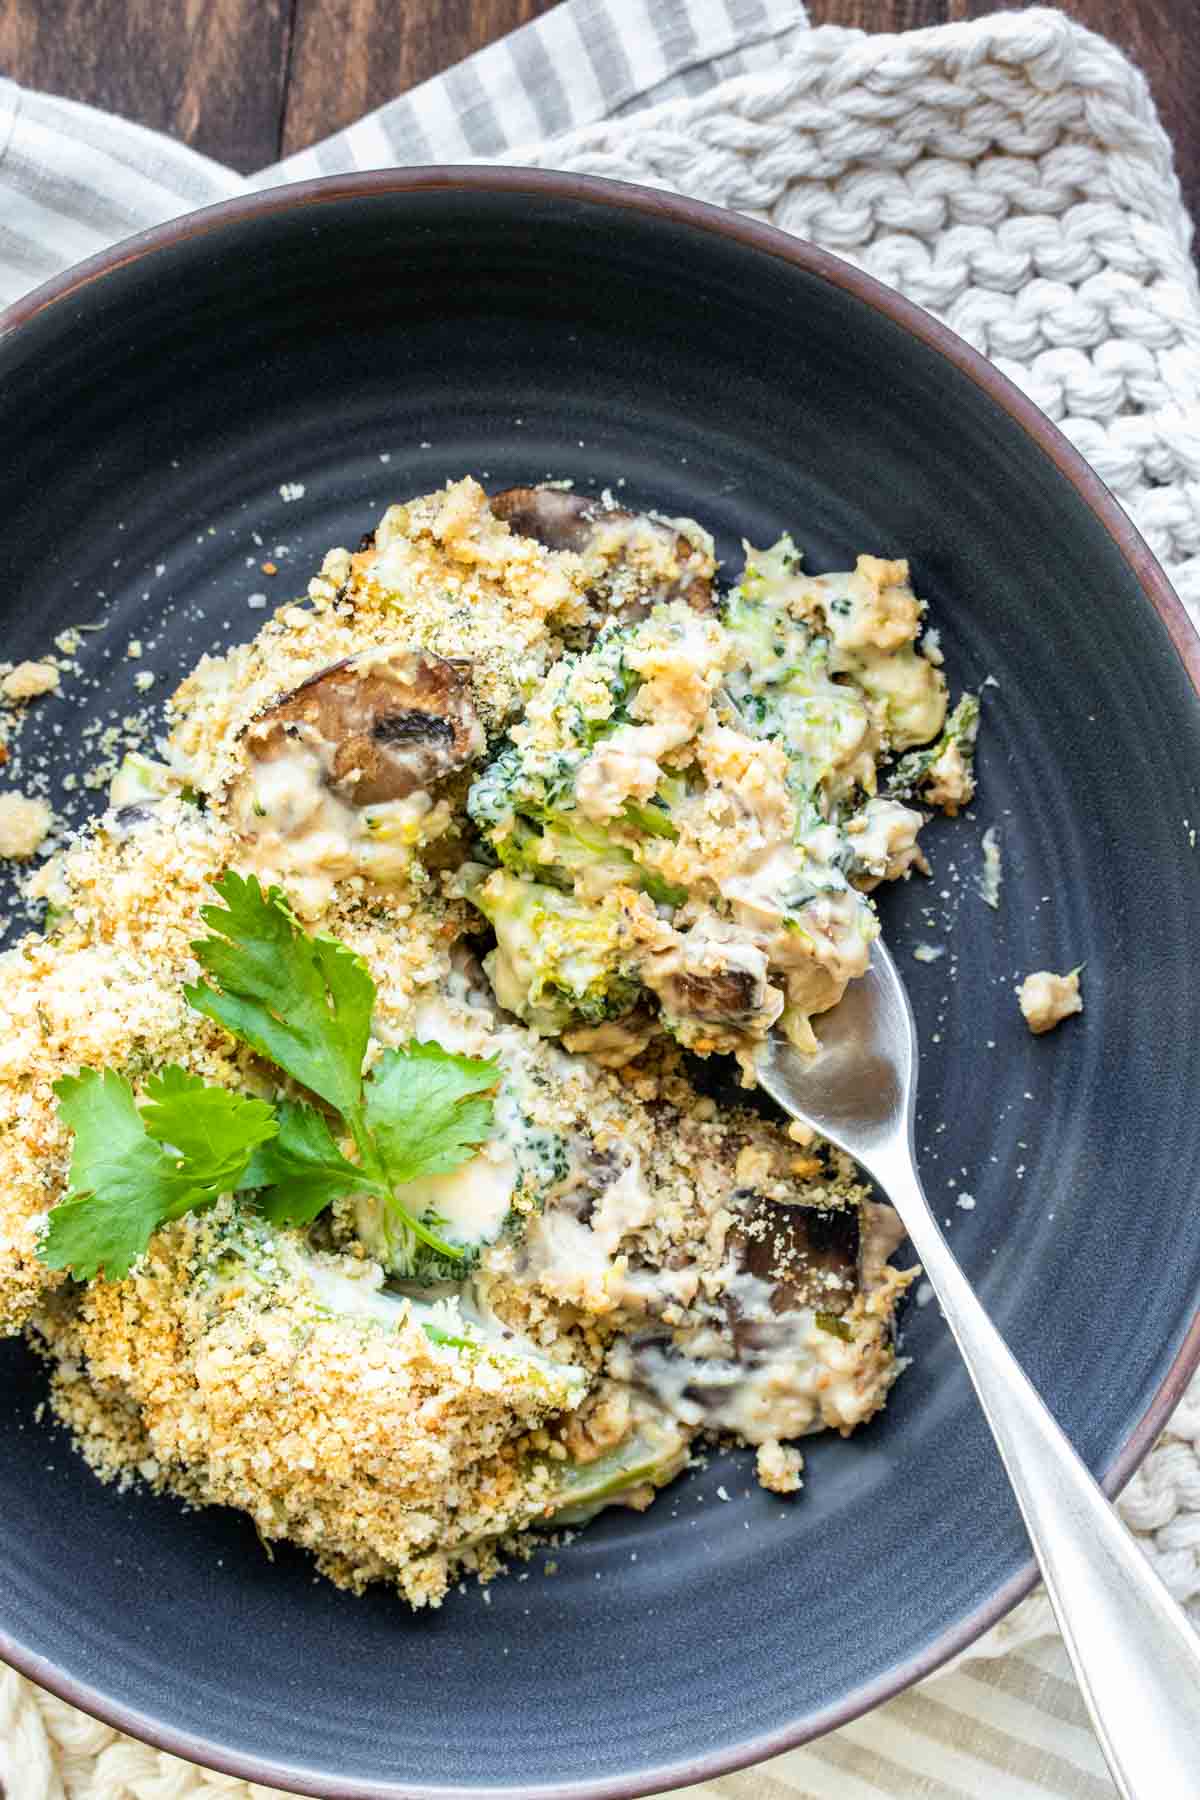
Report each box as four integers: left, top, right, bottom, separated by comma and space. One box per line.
0, 11, 1200, 1800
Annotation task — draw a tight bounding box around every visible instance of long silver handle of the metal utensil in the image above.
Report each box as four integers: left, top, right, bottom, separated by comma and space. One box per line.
888, 1157, 1200, 1800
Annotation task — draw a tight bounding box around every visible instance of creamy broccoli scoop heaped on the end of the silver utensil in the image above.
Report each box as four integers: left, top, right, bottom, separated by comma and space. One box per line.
456, 536, 966, 1055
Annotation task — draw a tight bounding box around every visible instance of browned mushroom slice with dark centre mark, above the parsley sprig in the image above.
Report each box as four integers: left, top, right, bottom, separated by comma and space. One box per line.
246, 650, 484, 806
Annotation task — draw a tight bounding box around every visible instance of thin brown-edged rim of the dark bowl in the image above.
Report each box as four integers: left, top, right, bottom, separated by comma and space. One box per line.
0, 164, 1200, 1800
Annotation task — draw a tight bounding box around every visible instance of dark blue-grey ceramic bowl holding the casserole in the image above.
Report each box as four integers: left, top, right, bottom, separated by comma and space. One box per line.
0, 169, 1200, 1800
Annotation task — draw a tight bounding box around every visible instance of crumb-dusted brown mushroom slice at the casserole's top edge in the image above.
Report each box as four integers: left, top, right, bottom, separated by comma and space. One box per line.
489, 488, 714, 621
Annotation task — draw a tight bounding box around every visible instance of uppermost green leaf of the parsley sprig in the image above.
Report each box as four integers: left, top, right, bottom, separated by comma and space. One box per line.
184, 869, 374, 1120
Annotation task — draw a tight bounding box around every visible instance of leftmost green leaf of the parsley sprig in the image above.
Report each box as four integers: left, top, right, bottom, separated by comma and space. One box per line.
40, 1069, 275, 1282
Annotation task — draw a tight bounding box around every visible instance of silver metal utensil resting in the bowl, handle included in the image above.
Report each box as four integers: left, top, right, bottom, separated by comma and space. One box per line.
757, 943, 1200, 1800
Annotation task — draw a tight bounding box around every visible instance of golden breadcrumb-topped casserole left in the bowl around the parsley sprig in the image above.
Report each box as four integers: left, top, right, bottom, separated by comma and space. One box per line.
0, 479, 932, 1606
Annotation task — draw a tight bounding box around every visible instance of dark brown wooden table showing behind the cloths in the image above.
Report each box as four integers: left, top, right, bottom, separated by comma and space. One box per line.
0, 0, 1200, 228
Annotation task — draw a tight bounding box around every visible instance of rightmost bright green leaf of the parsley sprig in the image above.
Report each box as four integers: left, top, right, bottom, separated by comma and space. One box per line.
367, 1040, 500, 1195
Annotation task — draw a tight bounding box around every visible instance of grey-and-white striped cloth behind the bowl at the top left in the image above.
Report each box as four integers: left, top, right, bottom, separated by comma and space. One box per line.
0, 0, 808, 306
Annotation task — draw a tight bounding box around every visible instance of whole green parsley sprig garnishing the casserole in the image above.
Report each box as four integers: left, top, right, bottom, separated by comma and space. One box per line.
41, 871, 500, 1280
